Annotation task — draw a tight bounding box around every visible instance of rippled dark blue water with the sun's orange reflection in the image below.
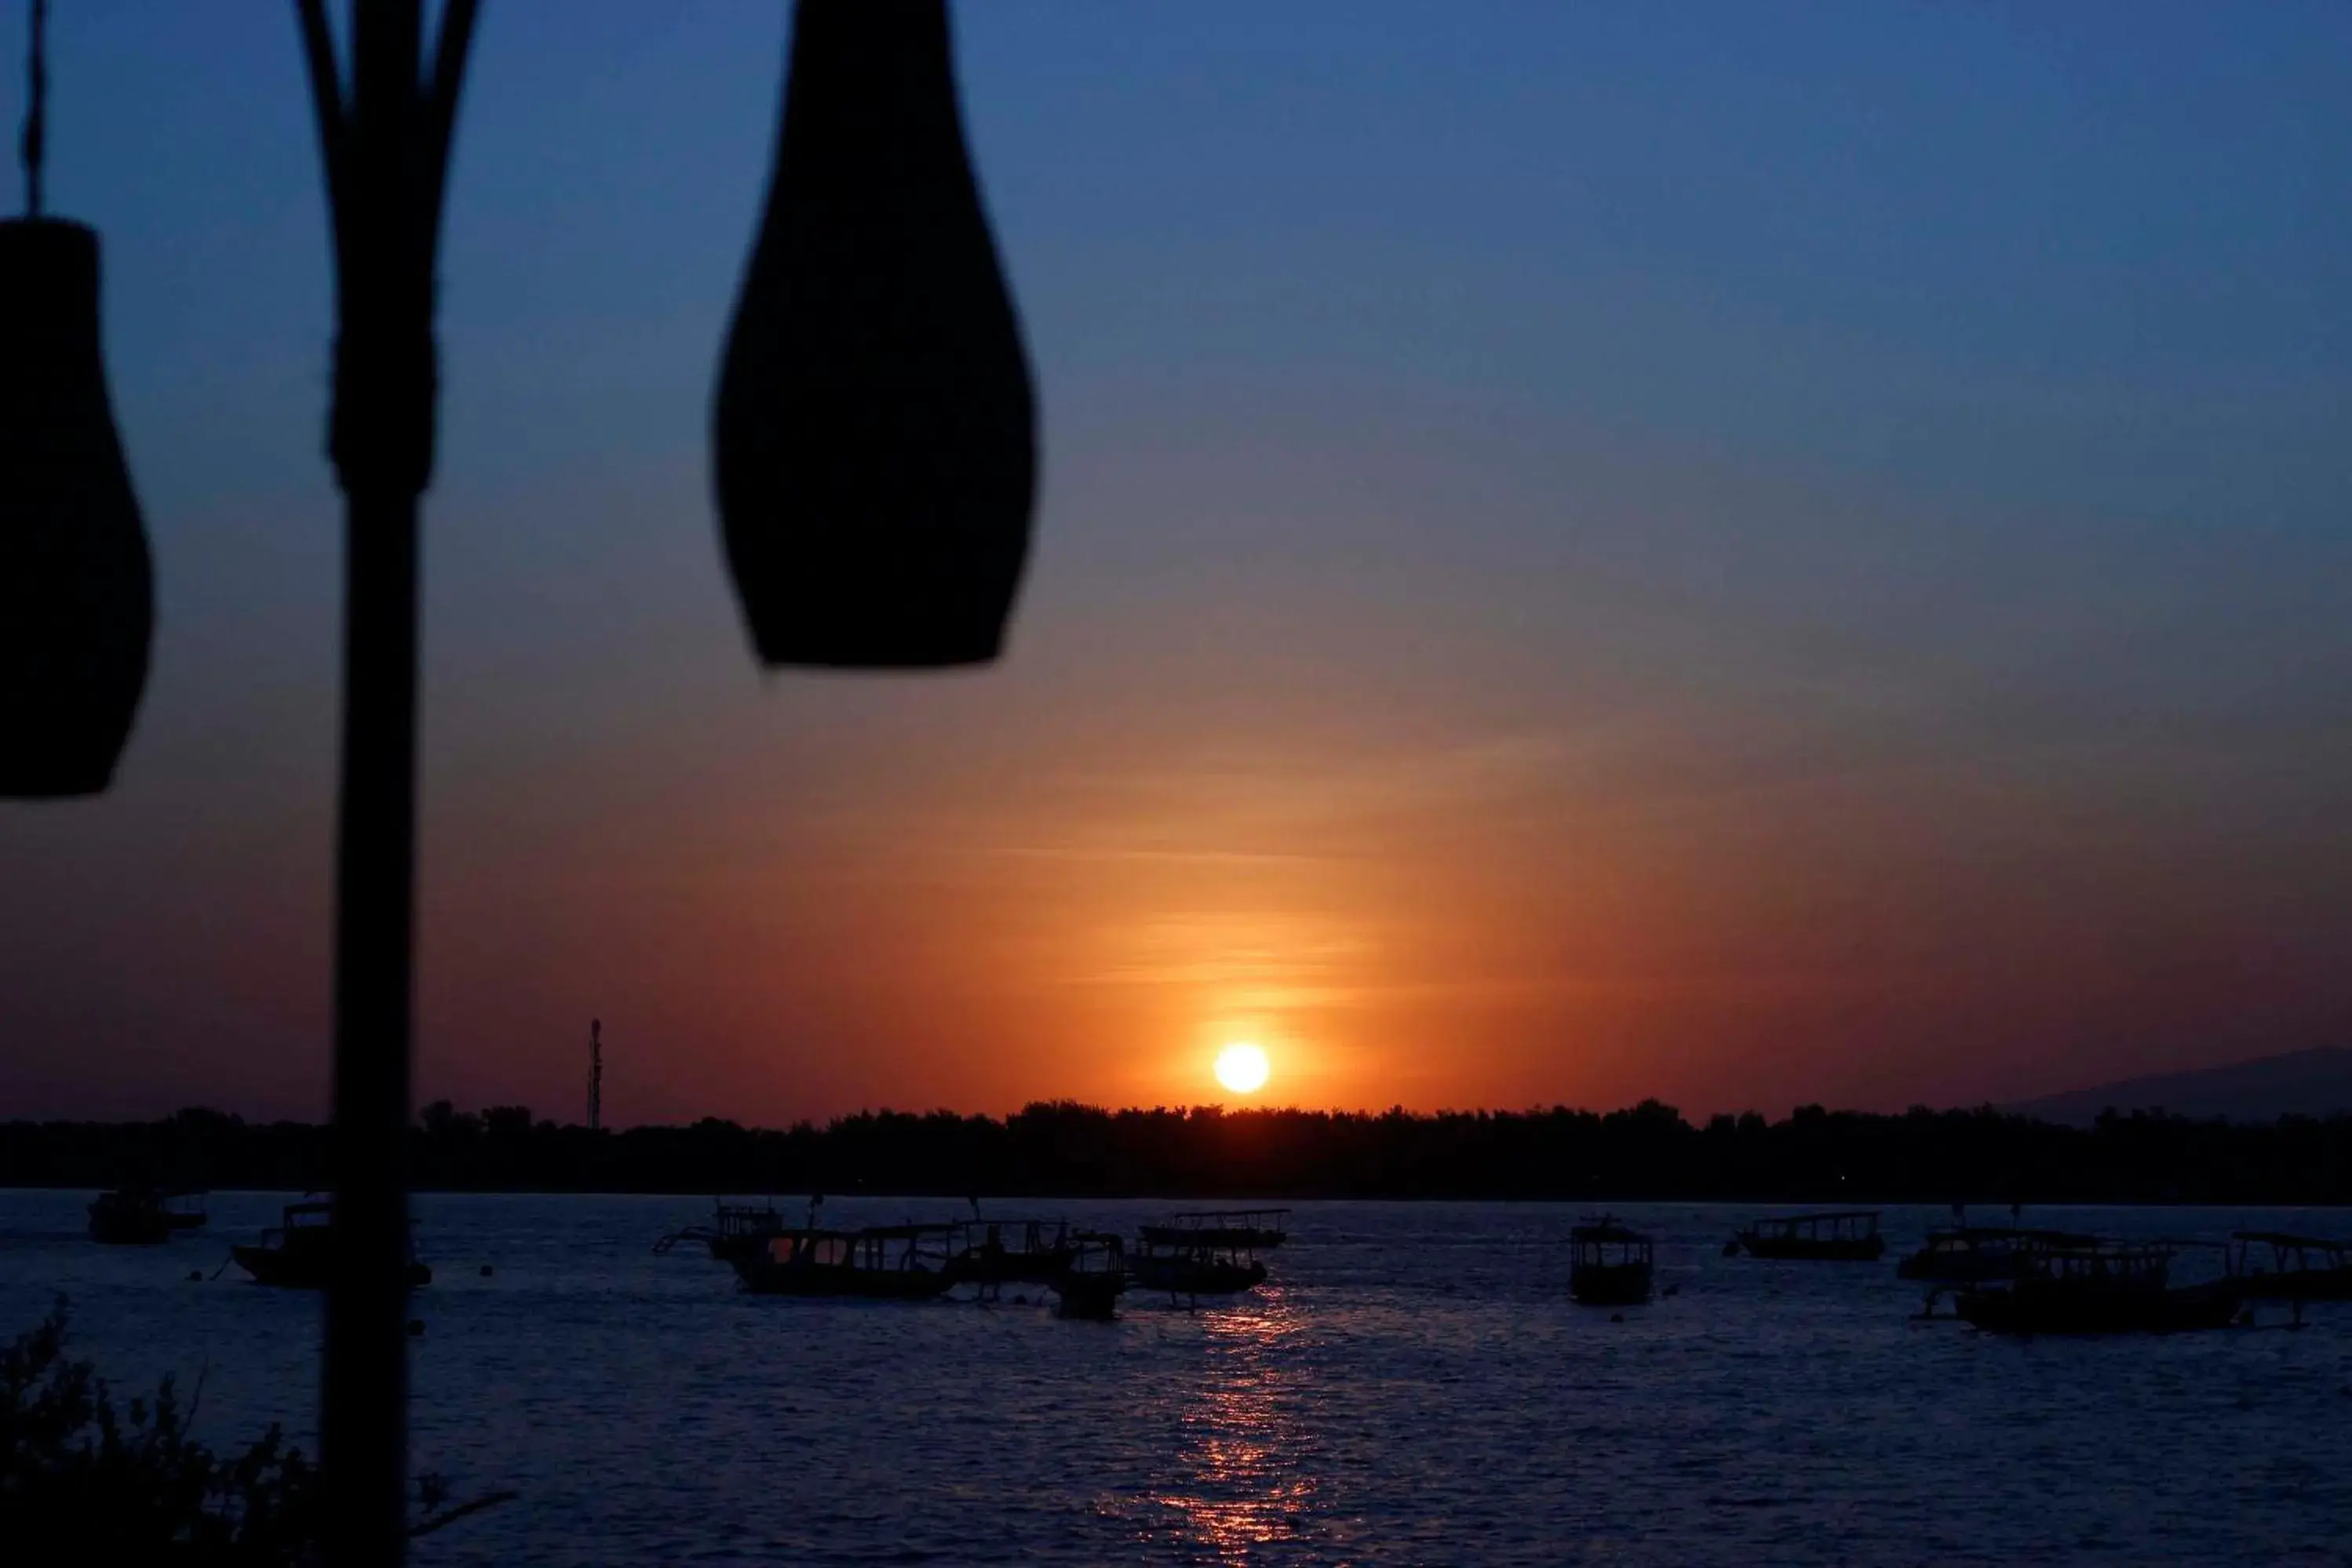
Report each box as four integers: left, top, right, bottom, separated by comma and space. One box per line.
0, 1192, 2352, 1566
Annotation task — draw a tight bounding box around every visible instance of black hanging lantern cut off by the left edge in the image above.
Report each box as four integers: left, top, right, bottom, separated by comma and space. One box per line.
0, 219, 155, 799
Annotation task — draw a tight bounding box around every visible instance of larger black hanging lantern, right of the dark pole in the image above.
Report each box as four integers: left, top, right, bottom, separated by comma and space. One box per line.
713, 0, 1037, 668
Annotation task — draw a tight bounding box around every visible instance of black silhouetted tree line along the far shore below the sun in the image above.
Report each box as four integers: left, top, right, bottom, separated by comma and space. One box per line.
0, 1100, 2352, 1204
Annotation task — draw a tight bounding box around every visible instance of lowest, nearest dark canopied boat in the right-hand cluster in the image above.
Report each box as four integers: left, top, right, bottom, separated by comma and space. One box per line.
1955, 1244, 2246, 1335
